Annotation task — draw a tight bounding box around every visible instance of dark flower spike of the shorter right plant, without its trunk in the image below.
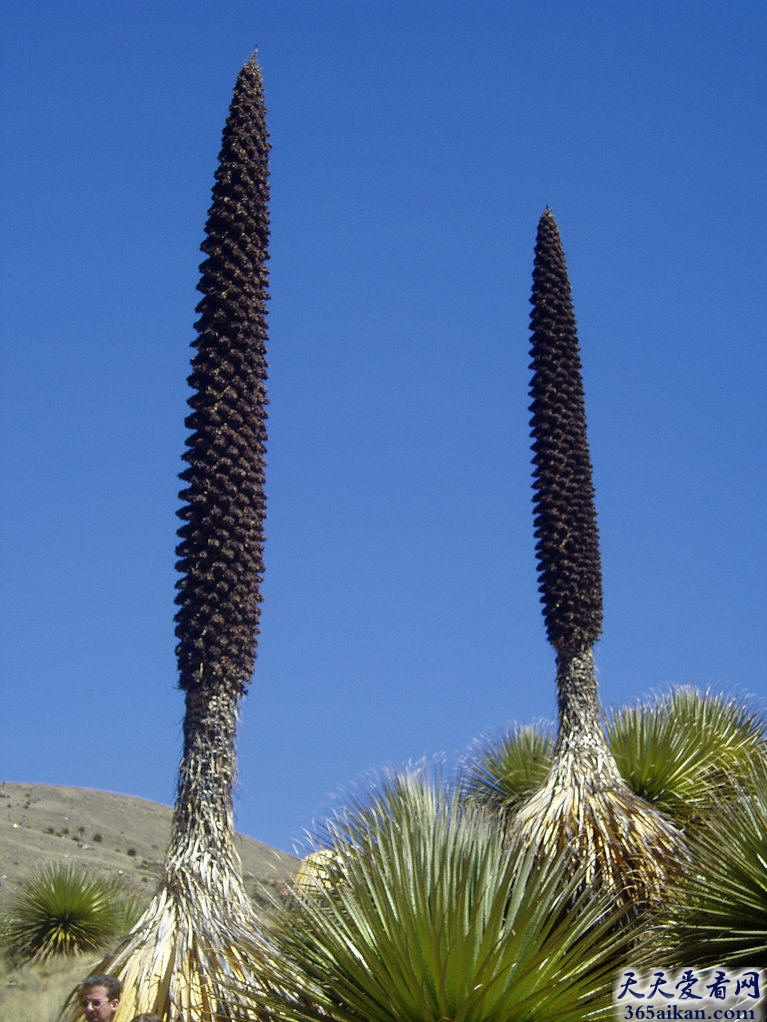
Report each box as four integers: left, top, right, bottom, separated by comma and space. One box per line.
530, 207, 602, 653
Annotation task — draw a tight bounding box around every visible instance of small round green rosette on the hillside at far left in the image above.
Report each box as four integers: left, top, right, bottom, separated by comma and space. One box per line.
5, 863, 141, 961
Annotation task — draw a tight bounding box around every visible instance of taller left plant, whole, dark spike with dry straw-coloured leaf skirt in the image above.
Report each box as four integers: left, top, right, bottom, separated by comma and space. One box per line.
60, 55, 269, 1022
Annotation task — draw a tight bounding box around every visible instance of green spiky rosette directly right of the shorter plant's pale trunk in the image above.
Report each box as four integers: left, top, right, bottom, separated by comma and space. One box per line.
606, 686, 767, 832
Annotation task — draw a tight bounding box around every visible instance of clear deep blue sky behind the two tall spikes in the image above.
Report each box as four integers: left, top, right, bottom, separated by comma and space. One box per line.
0, 0, 767, 849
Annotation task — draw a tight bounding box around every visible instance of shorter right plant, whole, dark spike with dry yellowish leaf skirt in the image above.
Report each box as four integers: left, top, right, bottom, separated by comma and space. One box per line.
515, 208, 681, 902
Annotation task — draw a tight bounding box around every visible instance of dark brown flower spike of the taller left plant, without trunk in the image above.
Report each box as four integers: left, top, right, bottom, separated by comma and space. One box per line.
176, 56, 269, 691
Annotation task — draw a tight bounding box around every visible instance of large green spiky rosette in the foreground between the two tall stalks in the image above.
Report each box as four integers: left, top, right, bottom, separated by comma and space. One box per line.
256, 774, 642, 1022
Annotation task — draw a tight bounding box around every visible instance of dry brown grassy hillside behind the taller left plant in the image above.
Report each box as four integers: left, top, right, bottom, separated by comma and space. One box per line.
0, 782, 298, 914
